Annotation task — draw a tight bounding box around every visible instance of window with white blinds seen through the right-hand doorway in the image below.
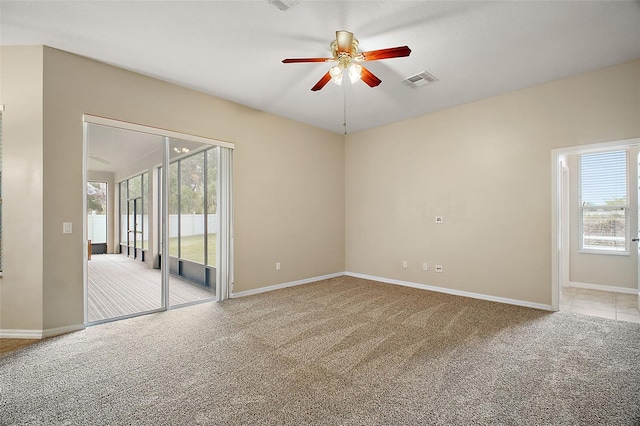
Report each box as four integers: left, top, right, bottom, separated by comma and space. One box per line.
580, 150, 629, 254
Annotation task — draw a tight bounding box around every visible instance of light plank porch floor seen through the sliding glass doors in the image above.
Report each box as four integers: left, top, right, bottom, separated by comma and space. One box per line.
88, 254, 215, 322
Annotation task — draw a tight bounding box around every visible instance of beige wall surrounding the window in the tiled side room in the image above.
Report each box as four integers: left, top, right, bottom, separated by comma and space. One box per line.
567, 151, 638, 289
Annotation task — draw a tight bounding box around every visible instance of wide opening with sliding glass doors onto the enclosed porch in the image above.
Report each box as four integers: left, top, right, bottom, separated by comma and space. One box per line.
84, 115, 233, 324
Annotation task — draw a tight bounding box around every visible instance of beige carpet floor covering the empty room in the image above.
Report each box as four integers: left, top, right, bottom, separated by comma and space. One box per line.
0, 277, 640, 425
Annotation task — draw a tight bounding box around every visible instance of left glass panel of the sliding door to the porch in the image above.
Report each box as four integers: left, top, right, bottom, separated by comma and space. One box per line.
86, 124, 165, 323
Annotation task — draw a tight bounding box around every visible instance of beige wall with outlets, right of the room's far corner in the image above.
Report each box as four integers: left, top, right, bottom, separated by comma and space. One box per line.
345, 60, 640, 305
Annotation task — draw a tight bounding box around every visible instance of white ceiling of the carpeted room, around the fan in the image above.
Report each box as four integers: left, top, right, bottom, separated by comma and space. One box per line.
0, 0, 640, 133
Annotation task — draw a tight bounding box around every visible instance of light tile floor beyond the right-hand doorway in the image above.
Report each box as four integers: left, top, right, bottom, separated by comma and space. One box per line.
560, 287, 640, 323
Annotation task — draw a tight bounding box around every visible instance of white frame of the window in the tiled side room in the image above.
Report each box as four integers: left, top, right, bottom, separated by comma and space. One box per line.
577, 148, 631, 256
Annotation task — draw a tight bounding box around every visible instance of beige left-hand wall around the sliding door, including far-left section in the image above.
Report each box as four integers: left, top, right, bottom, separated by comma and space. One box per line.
0, 47, 344, 330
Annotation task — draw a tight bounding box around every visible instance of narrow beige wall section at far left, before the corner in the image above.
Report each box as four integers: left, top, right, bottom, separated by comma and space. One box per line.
0, 47, 44, 330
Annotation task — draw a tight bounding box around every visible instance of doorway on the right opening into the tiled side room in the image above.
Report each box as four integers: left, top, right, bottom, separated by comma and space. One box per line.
552, 139, 640, 322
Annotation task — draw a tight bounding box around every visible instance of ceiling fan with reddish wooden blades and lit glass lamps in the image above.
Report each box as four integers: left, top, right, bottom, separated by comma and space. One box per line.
282, 30, 411, 92
